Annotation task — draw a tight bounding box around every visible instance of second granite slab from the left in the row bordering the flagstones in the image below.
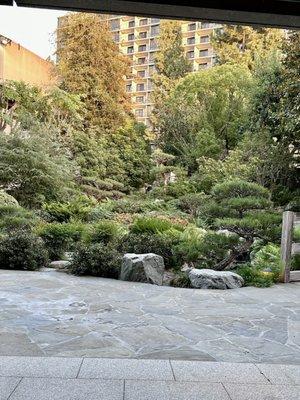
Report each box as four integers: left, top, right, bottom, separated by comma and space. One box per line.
79, 358, 174, 380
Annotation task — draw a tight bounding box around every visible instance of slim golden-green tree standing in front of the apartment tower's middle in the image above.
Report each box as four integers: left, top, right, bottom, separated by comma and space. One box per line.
152, 20, 192, 125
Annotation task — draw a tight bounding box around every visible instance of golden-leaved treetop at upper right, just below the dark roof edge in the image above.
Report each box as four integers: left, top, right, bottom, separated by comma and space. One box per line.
212, 25, 284, 70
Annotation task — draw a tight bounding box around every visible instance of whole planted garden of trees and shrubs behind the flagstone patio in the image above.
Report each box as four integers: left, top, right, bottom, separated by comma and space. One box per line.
0, 14, 300, 288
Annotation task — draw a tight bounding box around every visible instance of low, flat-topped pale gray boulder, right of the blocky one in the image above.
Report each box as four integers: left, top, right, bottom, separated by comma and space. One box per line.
188, 268, 244, 290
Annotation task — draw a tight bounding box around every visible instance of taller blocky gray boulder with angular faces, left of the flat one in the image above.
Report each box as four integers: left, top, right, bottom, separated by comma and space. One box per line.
120, 253, 165, 285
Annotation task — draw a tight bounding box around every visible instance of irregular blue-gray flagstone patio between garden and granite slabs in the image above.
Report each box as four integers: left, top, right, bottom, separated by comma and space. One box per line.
0, 270, 300, 362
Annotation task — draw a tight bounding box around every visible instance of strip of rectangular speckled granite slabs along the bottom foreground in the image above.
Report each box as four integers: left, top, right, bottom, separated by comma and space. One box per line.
0, 357, 300, 400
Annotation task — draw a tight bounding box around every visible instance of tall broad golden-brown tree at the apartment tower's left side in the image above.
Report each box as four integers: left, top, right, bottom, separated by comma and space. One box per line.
57, 13, 130, 130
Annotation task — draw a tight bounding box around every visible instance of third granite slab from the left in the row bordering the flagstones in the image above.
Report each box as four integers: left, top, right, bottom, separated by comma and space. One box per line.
171, 360, 269, 384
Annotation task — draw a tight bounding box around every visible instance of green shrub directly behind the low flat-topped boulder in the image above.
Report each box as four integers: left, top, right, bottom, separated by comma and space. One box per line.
176, 229, 239, 269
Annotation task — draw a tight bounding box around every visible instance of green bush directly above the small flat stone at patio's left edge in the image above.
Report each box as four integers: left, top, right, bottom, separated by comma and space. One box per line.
37, 222, 85, 260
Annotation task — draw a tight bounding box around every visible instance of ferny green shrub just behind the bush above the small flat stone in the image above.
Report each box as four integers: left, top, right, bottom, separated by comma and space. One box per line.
43, 196, 95, 222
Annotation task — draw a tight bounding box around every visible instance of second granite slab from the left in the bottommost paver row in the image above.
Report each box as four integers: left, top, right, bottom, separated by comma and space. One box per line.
10, 378, 124, 400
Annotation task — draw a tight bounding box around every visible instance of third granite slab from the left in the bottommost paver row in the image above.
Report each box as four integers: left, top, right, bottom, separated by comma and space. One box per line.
124, 381, 230, 400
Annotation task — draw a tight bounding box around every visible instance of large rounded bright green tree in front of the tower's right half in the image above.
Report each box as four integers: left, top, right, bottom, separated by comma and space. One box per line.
158, 65, 252, 172
